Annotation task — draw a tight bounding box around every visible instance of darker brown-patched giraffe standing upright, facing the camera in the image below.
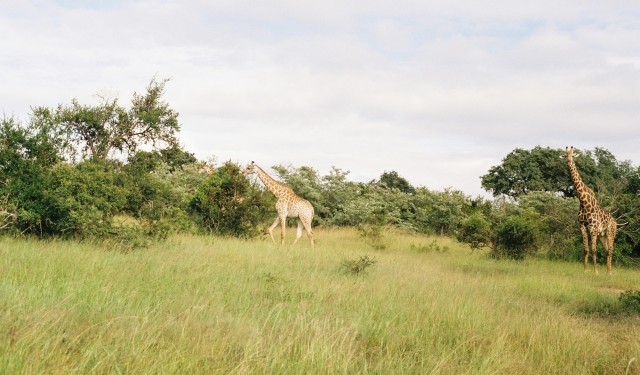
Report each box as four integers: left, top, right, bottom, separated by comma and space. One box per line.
565, 146, 618, 275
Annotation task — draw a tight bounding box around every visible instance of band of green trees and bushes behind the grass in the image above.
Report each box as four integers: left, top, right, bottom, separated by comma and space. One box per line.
0, 80, 640, 262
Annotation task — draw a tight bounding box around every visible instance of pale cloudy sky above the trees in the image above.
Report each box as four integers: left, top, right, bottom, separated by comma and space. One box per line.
0, 0, 640, 196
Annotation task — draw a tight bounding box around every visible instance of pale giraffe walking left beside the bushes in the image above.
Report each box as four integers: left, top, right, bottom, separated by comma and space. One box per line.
242, 161, 314, 248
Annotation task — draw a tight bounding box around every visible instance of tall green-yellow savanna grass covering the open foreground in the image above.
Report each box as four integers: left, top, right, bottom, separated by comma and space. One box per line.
0, 229, 640, 374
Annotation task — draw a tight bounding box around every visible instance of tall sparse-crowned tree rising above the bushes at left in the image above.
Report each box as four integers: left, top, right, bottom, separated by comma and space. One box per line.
32, 79, 180, 160
